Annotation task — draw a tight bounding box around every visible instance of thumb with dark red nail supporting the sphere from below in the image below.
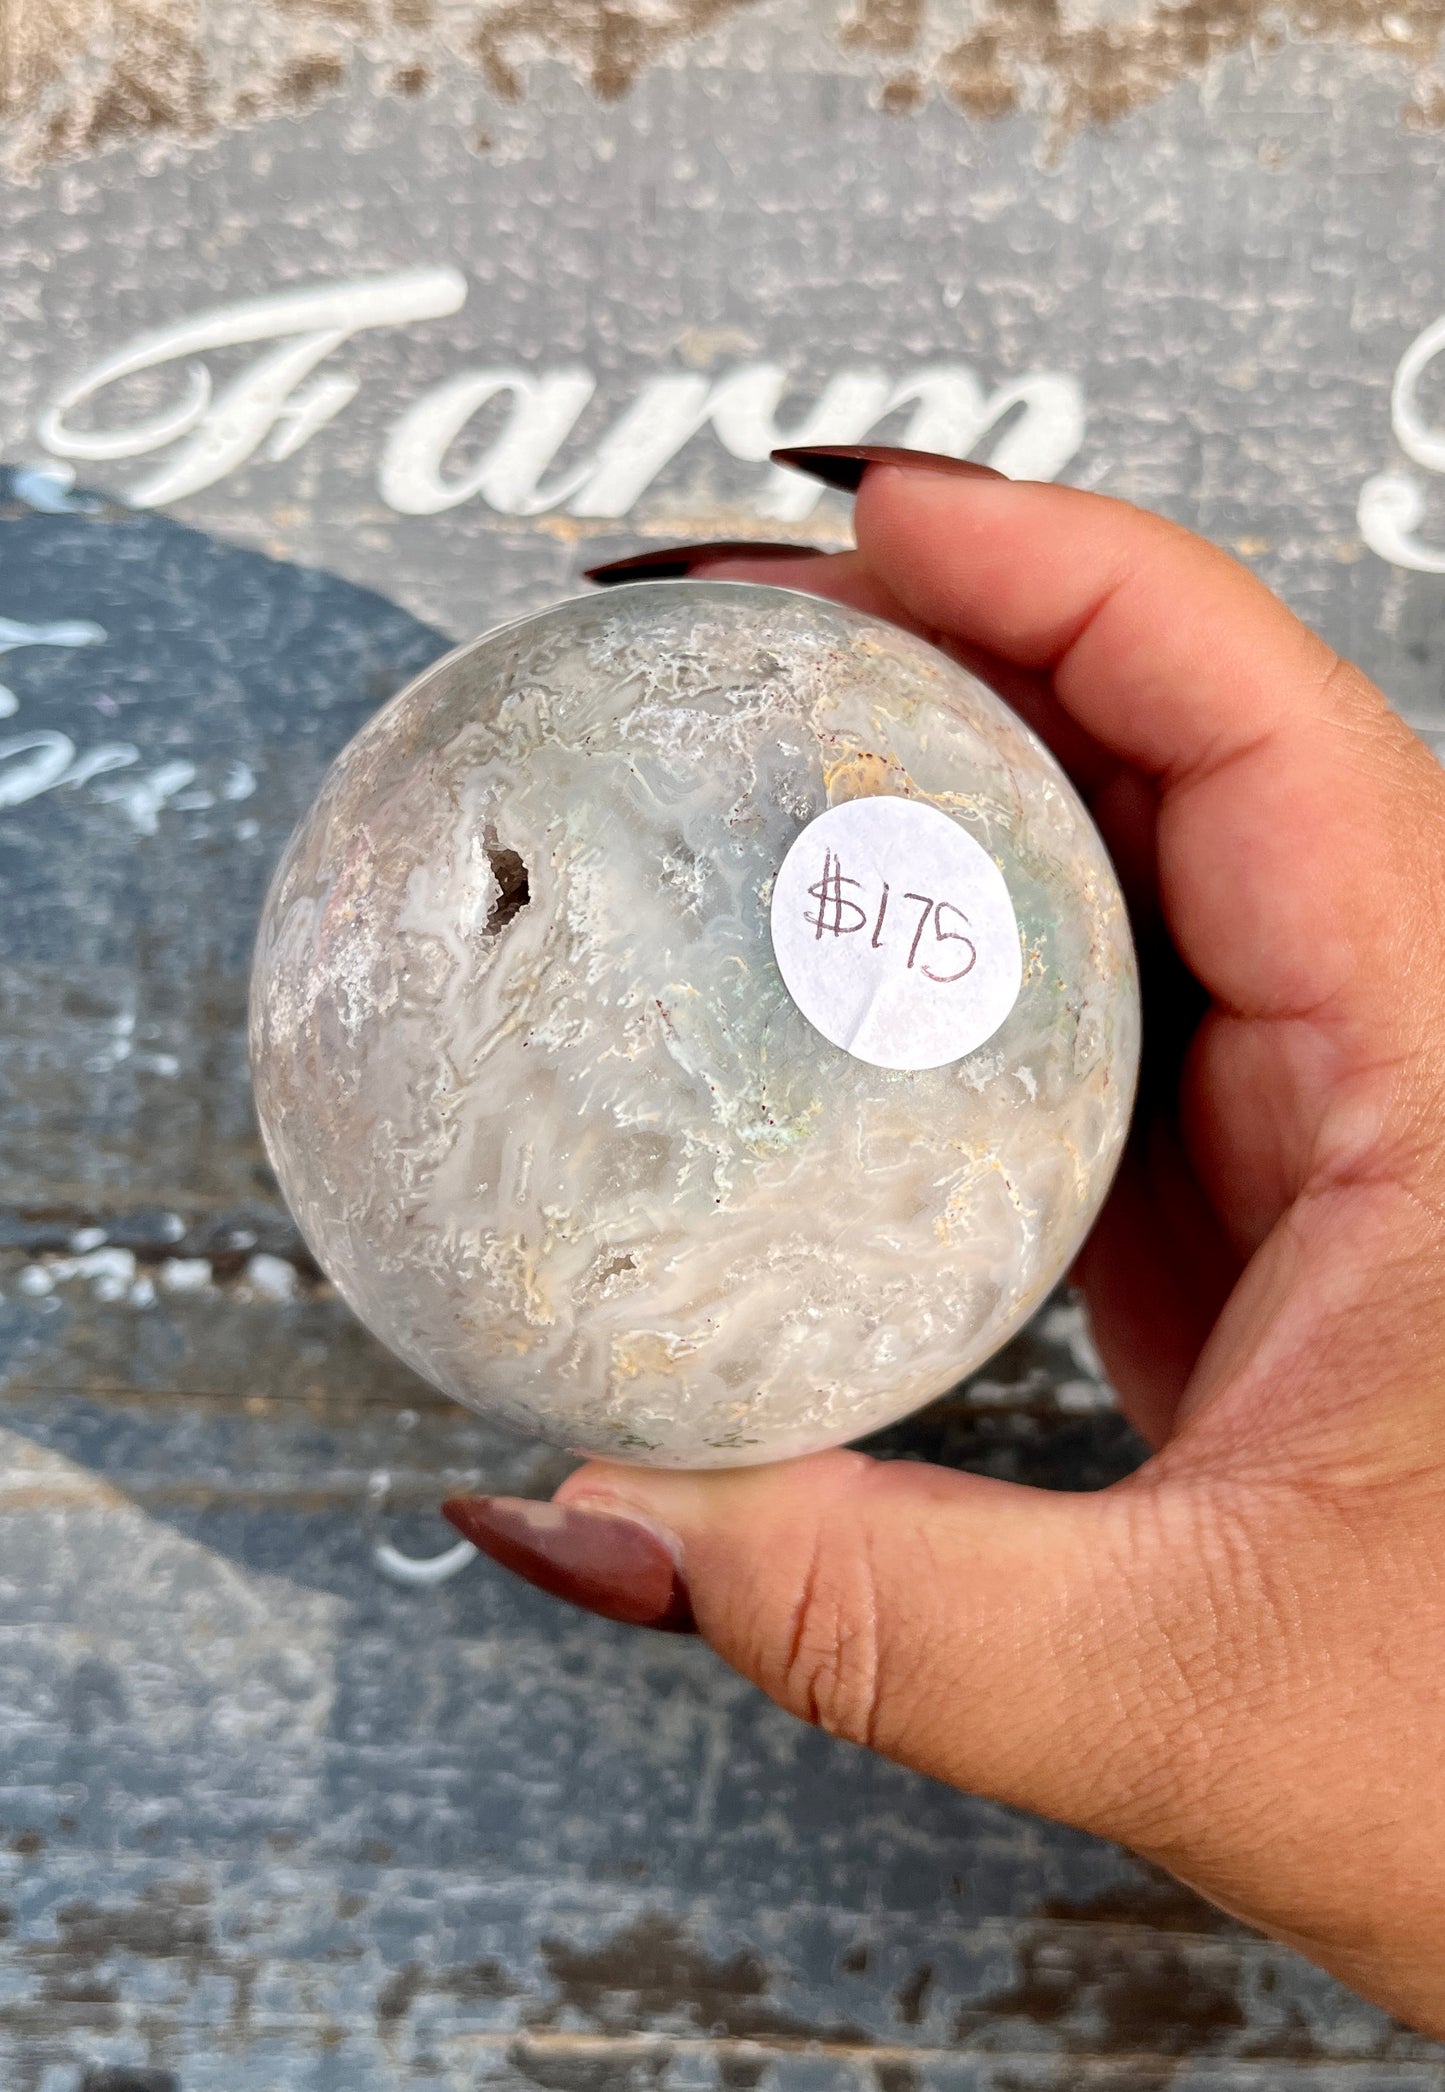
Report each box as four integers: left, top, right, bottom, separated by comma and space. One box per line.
448, 1452, 1192, 1843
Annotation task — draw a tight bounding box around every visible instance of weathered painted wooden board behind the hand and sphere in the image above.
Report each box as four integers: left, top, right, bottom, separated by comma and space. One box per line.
0, 0, 1445, 2092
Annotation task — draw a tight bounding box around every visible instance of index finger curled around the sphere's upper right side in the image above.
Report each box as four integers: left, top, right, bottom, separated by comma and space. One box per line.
857, 464, 1445, 1046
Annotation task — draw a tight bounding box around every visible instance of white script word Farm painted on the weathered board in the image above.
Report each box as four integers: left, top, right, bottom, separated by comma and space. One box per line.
40, 268, 1083, 521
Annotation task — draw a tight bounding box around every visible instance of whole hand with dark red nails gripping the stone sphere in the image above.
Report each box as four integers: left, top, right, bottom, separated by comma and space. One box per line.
450, 460, 1445, 2033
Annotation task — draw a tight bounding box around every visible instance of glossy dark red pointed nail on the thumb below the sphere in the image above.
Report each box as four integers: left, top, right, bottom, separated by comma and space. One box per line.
441, 1496, 696, 1634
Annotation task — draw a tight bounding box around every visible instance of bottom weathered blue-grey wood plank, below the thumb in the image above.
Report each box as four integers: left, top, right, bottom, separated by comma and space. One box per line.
0, 1510, 1439, 2092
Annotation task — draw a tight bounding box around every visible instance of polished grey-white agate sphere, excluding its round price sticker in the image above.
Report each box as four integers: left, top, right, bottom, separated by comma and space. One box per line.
251, 582, 1138, 1466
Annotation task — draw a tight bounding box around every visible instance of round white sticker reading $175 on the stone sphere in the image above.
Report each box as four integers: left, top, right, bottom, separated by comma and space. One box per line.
772, 797, 1023, 1069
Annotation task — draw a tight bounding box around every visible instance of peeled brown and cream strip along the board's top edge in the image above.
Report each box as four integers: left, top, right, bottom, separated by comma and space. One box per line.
0, 0, 1445, 172
